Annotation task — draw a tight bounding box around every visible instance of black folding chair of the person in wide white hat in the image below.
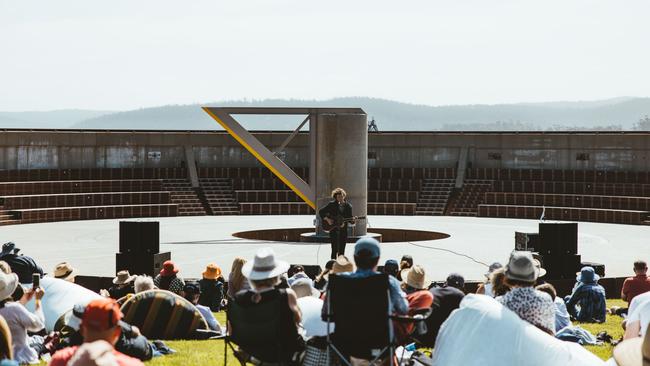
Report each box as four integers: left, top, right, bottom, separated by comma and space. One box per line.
224, 297, 299, 365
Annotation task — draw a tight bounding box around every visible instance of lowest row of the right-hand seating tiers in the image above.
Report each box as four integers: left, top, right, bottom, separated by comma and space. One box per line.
478, 204, 648, 225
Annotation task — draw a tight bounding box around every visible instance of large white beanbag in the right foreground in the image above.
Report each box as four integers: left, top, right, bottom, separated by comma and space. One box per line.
433, 295, 604, 366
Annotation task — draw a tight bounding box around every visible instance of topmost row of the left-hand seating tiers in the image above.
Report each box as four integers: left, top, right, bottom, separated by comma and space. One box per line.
0, 168, 187, 182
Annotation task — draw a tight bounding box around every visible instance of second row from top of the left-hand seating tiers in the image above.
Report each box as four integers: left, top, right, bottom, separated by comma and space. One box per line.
0, 179, 162, 195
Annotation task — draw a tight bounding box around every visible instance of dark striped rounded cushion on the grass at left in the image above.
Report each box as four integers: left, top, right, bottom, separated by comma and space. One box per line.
122, 290, 208, 339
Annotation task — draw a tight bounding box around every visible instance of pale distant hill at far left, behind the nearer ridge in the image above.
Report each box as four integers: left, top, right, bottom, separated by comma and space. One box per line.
0, 109, 113, 128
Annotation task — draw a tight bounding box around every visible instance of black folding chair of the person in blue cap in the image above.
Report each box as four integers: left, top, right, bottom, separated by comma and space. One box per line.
326, 273, 395, 366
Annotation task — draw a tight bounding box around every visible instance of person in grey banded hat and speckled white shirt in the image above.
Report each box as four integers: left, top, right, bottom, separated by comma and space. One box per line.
497, 251, 555, 335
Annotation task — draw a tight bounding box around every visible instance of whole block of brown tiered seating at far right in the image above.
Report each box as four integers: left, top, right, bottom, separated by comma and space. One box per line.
468, 169, 650, 224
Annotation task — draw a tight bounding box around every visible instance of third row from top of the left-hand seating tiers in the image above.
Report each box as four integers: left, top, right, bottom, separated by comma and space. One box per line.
0, 192, 170, 210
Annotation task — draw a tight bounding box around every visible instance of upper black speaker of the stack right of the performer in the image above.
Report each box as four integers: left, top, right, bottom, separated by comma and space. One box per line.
536, 222, 578, 255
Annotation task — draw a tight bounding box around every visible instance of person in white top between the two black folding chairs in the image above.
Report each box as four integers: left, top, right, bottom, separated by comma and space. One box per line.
291, 278, 334, 339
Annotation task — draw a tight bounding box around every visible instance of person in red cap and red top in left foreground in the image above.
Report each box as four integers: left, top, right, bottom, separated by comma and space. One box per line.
49, 298, 144, 366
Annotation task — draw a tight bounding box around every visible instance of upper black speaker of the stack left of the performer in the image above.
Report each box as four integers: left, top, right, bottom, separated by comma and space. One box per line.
120, 221, 160, 254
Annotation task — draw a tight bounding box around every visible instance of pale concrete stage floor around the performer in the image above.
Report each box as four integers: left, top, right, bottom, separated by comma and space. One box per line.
0, 216, 650, 280
